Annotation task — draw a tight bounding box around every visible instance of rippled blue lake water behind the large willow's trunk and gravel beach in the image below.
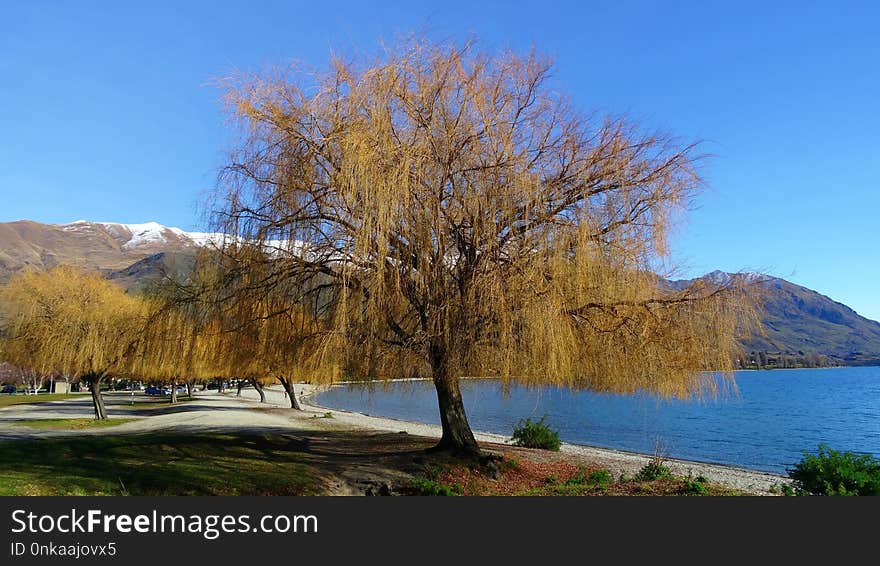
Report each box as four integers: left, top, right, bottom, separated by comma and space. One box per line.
317, 367, 880, 474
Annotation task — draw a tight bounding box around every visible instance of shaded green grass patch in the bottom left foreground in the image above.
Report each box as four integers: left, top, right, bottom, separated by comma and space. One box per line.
0, 434, 319, 495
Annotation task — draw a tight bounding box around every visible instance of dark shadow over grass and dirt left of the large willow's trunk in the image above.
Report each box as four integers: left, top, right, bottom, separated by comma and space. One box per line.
0, 428, 433, 495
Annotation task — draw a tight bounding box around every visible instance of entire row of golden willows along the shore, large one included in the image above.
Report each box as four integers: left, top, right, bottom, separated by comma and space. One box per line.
2, 39, 756, 455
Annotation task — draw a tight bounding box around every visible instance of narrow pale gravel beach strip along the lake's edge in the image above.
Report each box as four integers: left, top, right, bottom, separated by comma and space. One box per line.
296, 380, 791, 494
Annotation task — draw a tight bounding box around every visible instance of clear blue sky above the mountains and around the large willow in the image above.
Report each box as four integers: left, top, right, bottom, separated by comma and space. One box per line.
0, 0, 880, 319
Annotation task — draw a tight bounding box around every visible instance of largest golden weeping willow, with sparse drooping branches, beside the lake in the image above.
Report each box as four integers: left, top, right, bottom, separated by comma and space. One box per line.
217, 41, 749, 453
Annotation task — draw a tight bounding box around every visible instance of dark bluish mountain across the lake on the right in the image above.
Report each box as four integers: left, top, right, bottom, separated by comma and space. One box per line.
671, 271, 880, 367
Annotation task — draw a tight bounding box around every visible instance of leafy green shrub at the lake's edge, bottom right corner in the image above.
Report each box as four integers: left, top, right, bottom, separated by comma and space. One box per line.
789, 444, 880, 495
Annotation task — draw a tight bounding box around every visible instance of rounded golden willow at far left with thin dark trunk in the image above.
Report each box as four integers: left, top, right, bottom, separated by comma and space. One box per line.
0, 267, 147, 419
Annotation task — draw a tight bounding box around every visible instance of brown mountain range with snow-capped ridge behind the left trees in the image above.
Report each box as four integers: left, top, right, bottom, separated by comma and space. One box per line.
0, 220, 215, 281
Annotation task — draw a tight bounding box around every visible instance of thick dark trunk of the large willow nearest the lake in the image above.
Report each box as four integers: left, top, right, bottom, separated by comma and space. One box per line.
431, 346, 480, 456
